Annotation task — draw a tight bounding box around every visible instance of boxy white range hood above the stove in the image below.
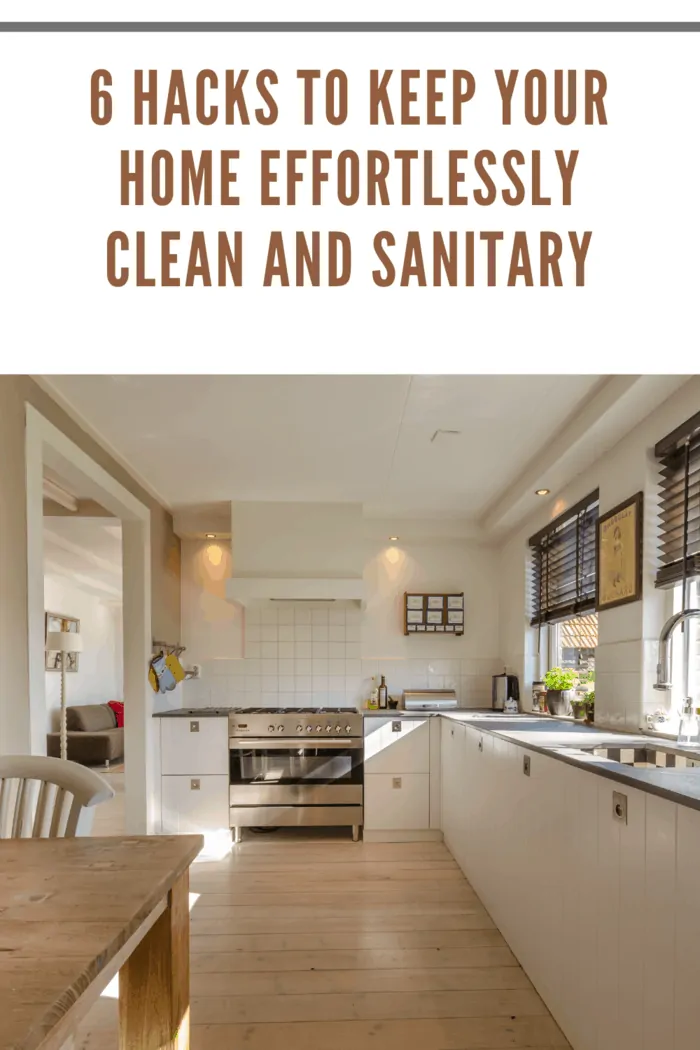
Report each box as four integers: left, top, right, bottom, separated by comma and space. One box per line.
226, 503, 364, 605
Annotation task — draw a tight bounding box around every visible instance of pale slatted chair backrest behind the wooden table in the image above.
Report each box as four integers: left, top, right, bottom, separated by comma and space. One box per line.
0, 755, 114, 839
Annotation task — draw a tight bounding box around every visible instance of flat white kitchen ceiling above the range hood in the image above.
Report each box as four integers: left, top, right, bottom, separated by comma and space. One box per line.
42, 375, 604, 520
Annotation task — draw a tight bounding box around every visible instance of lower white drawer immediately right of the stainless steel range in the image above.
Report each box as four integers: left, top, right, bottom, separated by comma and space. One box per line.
364, 773, 430, 832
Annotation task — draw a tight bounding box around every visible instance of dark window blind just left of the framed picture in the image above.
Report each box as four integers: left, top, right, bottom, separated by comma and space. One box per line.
529, 489, 598, 626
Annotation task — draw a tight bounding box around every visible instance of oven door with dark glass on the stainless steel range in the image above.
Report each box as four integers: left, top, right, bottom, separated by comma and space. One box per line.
229, 737, 363, 805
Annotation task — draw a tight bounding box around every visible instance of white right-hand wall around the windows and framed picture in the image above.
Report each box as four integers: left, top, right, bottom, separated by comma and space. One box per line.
497, 377, 700, 730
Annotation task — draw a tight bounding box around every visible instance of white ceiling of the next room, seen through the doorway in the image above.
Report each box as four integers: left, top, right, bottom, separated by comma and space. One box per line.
44, 517, 122, 602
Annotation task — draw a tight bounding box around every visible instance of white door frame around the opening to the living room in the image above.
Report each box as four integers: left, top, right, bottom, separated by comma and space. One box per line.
25, 402, 160, 835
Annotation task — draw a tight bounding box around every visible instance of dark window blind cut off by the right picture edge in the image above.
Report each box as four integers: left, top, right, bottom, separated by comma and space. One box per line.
655, 413, 700, 587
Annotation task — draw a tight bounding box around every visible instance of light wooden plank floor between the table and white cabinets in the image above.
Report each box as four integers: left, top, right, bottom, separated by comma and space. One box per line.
76, 831, 568, 1050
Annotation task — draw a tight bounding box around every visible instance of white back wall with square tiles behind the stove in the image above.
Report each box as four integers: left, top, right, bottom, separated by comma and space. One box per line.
182, 529, 502, 707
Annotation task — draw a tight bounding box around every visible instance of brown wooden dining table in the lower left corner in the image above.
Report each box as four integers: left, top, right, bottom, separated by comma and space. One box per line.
0, 835, 204, 1050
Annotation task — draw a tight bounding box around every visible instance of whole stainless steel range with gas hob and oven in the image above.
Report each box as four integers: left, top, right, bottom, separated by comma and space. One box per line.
229, 708, 363, 840
